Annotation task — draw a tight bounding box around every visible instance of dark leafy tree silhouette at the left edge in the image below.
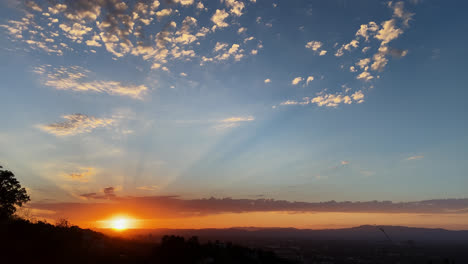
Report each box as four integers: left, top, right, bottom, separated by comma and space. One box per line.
0, 166, 30, 219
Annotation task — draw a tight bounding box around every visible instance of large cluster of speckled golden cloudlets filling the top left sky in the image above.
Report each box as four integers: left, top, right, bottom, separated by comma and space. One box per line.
0, 0, 261, 69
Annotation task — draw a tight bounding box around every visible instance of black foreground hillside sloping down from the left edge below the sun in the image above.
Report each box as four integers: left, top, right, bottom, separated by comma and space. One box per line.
0, 219, 293, 264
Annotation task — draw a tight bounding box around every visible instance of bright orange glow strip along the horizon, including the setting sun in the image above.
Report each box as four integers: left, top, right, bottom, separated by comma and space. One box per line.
50, 211, 468, 232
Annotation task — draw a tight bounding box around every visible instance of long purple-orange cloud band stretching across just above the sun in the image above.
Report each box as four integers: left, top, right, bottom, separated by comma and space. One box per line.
31, 196, 468, 221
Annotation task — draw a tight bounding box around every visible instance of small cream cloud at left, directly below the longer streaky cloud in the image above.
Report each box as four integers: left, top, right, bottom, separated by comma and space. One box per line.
38, 114, 115, 136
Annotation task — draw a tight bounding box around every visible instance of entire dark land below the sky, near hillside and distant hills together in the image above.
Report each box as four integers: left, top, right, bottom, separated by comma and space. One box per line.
0, 219, 468, 264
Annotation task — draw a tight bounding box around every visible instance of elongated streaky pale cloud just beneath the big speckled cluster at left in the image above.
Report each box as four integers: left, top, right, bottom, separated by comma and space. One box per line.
35, 66, 148, 99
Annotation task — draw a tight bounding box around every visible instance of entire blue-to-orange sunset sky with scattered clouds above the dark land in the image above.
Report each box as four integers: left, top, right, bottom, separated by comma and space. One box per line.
0, 0, 468, 229
